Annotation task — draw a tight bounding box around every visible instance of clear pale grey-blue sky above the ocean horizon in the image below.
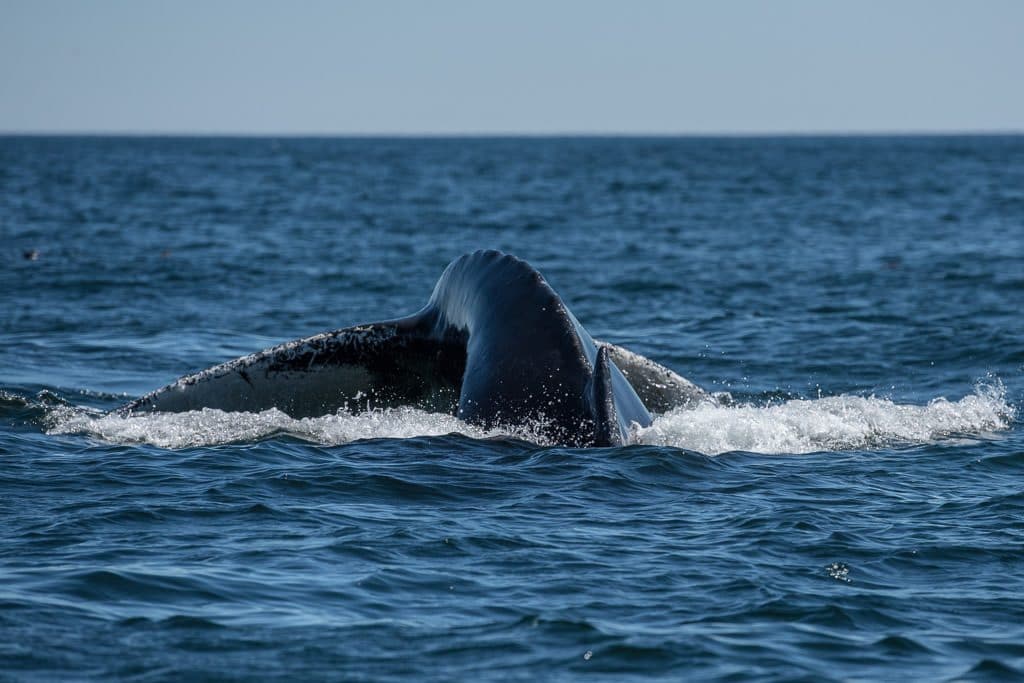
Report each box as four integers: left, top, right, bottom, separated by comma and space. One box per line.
0, 0, 1024, 134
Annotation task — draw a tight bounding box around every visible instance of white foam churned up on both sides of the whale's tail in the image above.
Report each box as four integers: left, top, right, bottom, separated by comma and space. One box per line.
47, 382, 1014, 455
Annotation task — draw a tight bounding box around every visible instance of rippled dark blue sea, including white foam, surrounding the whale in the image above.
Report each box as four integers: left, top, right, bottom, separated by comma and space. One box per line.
0, 137, 1024, 681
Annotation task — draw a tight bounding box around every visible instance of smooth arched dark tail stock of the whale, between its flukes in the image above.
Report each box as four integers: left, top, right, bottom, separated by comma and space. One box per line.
418, 251, 651, 445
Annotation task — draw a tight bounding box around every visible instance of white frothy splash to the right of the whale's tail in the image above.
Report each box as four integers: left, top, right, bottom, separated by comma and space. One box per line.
637, 380, 1014, 455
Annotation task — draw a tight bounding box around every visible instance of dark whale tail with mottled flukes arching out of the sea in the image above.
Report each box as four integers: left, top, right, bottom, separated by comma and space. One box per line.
118, 251, 708, 446
